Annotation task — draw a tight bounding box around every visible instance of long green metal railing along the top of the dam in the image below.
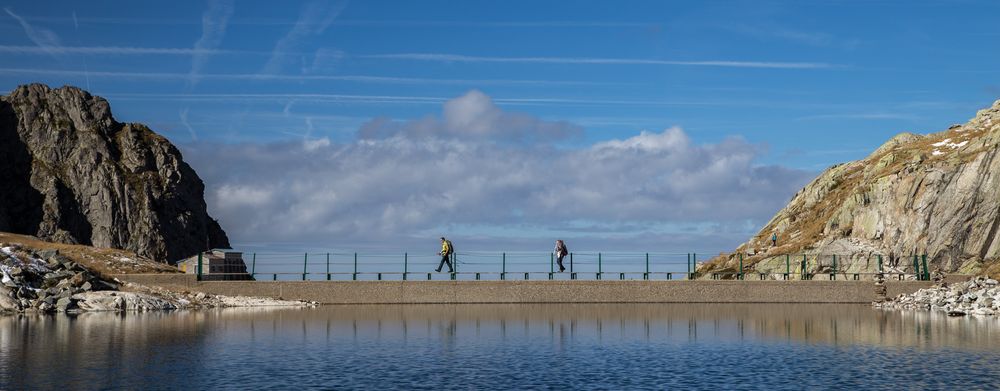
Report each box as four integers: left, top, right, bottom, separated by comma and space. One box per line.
197, 251, 931, 281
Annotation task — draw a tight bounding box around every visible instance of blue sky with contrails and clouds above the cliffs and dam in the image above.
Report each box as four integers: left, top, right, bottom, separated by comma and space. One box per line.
0, 0, 1000, 253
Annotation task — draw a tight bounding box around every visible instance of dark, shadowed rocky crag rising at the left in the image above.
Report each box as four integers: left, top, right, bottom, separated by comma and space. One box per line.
0, 84, 229, 263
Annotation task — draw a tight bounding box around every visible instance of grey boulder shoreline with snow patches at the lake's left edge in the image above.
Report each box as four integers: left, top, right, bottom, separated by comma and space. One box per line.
0, 244, 315, 313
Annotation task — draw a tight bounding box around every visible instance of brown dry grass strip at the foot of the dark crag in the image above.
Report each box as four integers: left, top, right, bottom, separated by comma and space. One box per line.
0, 232, 180, 277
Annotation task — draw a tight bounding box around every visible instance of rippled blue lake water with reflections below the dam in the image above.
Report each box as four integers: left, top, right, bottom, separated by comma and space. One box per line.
0, 304, 1000, 389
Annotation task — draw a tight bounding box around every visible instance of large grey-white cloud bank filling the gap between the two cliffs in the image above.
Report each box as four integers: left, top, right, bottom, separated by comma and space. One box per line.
185, 92, 811, 250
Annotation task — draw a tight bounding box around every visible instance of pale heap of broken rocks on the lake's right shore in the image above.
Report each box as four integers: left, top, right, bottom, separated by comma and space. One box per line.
872, 277, 1000, 316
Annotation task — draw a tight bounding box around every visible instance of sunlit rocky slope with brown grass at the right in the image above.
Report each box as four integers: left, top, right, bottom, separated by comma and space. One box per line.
704, 101, 1000, 273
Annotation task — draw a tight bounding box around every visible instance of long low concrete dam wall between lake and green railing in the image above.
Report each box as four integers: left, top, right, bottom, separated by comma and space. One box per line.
116, 274, 933, 304
